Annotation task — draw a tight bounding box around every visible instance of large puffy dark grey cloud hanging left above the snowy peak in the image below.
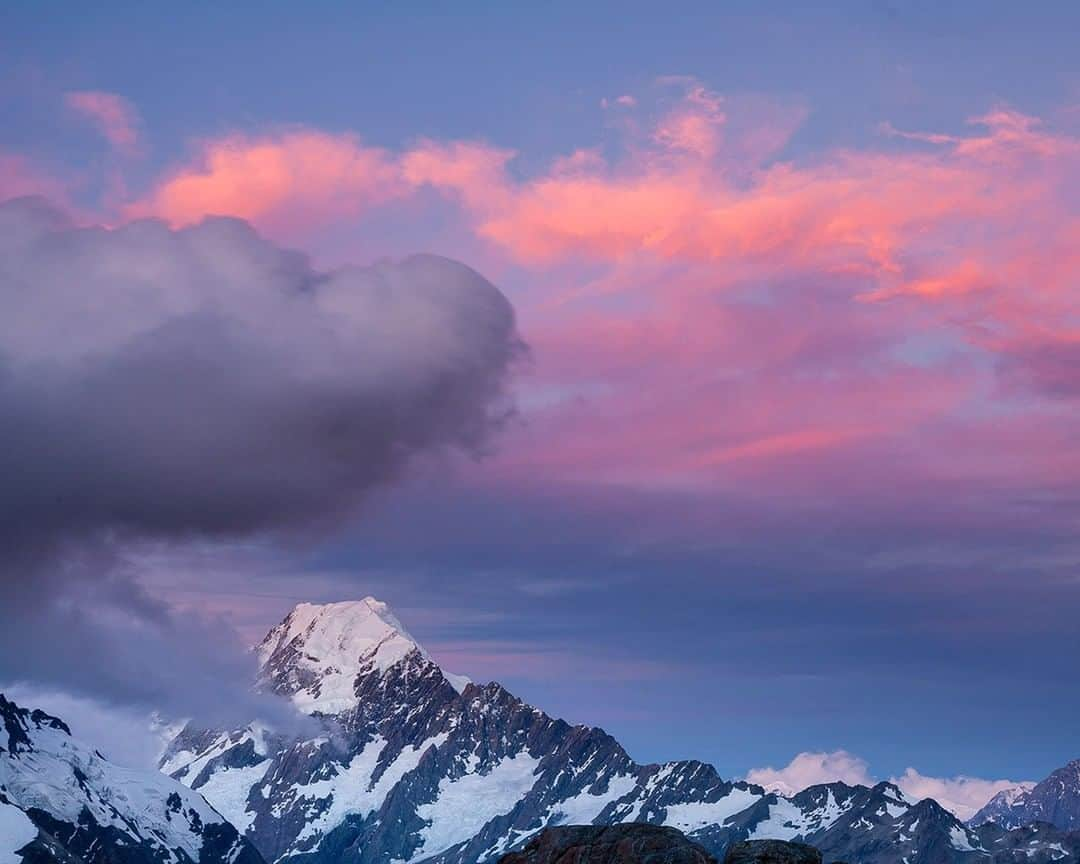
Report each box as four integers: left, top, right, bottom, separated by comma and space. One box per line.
0, 199, 522, 721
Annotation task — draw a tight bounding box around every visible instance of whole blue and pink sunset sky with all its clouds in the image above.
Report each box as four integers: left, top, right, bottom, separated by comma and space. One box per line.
0, 1, 1080, 806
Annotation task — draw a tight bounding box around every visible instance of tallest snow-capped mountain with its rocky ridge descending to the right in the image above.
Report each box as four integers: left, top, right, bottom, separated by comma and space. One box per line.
162, 598, 1080, 864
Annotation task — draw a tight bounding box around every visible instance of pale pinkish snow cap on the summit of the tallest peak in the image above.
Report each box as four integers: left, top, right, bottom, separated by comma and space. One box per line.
257, 597, 469, 714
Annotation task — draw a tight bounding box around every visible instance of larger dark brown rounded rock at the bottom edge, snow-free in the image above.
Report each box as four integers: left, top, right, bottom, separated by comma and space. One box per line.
499, 822, 717, 864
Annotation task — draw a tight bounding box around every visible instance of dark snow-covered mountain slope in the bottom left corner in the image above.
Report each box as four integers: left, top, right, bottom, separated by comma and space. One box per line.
0, 694, 262, 864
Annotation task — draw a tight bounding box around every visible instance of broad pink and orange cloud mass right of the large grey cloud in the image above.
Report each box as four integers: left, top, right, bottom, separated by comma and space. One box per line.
395, 91, 1080, 494
